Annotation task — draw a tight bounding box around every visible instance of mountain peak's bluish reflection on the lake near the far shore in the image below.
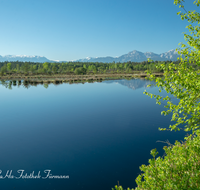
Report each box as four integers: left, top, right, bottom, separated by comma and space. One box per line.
103, 79, 156, 90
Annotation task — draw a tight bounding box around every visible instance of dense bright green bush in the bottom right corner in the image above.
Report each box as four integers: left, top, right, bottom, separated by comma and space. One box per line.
135, 131, 200, 190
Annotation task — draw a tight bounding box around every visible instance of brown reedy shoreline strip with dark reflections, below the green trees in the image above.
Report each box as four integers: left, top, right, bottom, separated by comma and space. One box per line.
0, 73, 163, 89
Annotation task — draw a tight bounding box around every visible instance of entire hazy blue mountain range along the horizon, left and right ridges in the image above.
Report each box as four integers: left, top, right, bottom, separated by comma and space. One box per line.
0, 50, 179, 63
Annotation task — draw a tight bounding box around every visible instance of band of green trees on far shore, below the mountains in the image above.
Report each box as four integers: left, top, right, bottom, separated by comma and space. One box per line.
0, 61, 184, 76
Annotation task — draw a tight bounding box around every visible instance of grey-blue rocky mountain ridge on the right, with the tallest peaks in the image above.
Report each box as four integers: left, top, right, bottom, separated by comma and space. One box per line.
76, 49, 179, 63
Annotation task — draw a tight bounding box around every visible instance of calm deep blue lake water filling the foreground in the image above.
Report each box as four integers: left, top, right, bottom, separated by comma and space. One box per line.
0, 79, 185, 190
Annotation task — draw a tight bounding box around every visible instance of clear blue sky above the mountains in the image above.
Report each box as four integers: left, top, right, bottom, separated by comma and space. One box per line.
0, 0, 196, 61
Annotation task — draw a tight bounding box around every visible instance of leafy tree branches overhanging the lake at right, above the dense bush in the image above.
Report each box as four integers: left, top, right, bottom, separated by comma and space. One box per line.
145, 0, 200, 132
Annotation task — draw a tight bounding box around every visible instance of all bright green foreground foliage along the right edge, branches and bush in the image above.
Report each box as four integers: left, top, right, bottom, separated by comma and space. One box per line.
112, 0, 200, 190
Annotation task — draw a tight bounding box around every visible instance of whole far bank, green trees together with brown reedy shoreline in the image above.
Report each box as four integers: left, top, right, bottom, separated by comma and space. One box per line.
0, 61, 198, 89
